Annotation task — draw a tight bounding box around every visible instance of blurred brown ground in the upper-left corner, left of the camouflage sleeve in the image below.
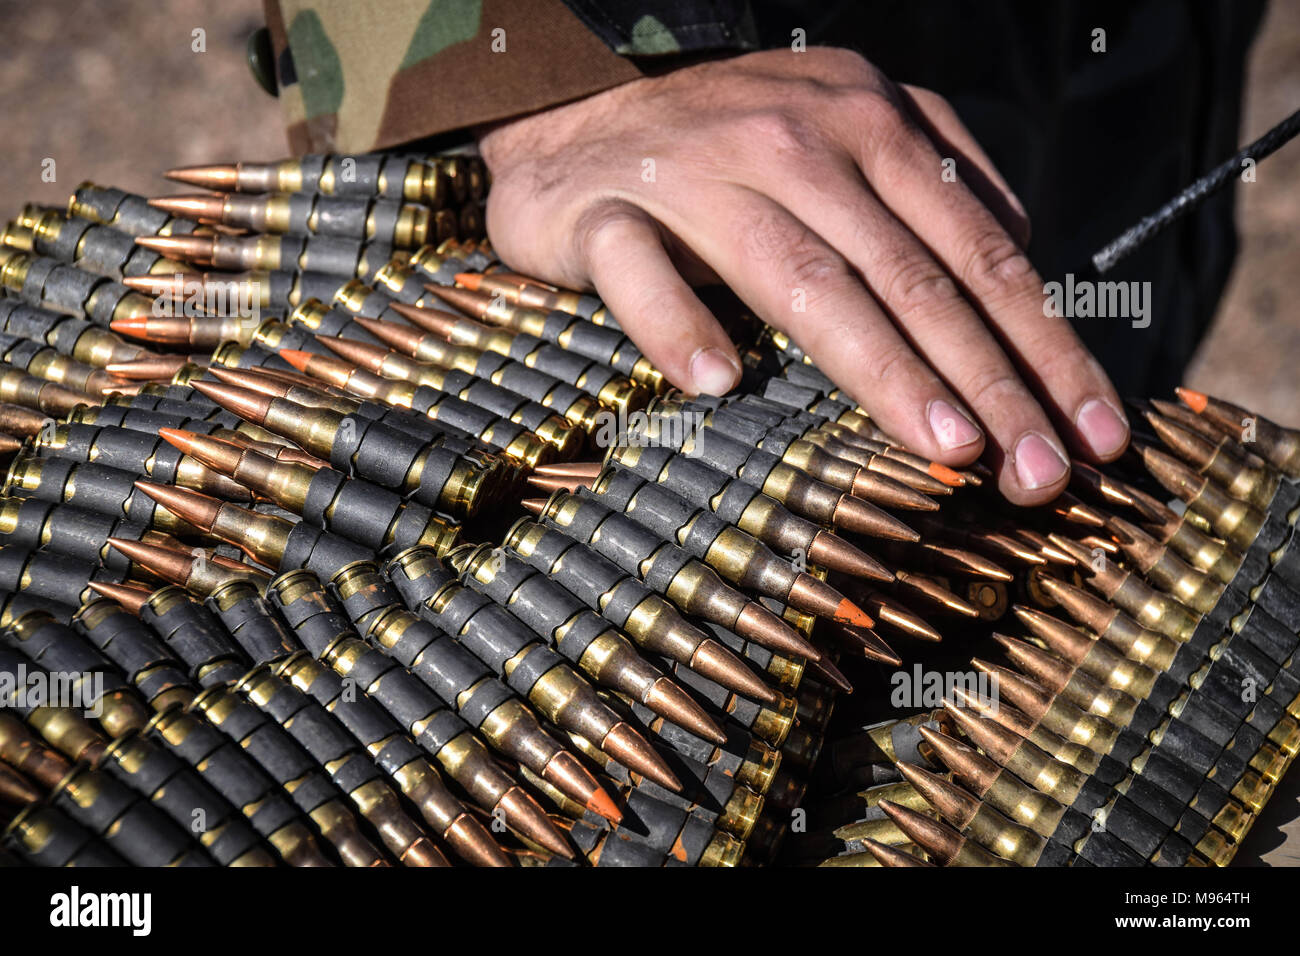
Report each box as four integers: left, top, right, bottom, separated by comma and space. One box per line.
0, 0, 287, 210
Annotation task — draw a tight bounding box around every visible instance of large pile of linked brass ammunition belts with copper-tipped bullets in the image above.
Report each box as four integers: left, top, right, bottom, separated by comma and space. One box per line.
0, 147, 1300, 866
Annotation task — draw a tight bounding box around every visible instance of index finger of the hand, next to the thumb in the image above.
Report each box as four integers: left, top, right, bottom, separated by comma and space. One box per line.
655, 187, 984, 464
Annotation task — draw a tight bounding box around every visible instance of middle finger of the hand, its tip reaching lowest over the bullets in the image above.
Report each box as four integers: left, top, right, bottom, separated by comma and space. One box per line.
743, 159, 1069, 503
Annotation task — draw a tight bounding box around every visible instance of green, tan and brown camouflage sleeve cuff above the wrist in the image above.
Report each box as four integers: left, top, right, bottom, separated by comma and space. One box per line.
264, 0, 754, 153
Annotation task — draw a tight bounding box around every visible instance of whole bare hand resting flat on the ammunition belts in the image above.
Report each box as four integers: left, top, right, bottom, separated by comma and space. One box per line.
480, 48, 1128, 505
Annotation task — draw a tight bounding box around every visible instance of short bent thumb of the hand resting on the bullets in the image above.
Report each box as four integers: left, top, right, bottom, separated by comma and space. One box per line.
576, 202, 740, 395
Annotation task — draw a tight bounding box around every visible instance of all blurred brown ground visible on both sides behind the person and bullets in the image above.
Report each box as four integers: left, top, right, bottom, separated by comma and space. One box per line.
0, 0, 1300, 864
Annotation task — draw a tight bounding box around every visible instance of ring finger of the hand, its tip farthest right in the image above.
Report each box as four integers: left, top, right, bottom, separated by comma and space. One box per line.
849, 85, 1128, 460
